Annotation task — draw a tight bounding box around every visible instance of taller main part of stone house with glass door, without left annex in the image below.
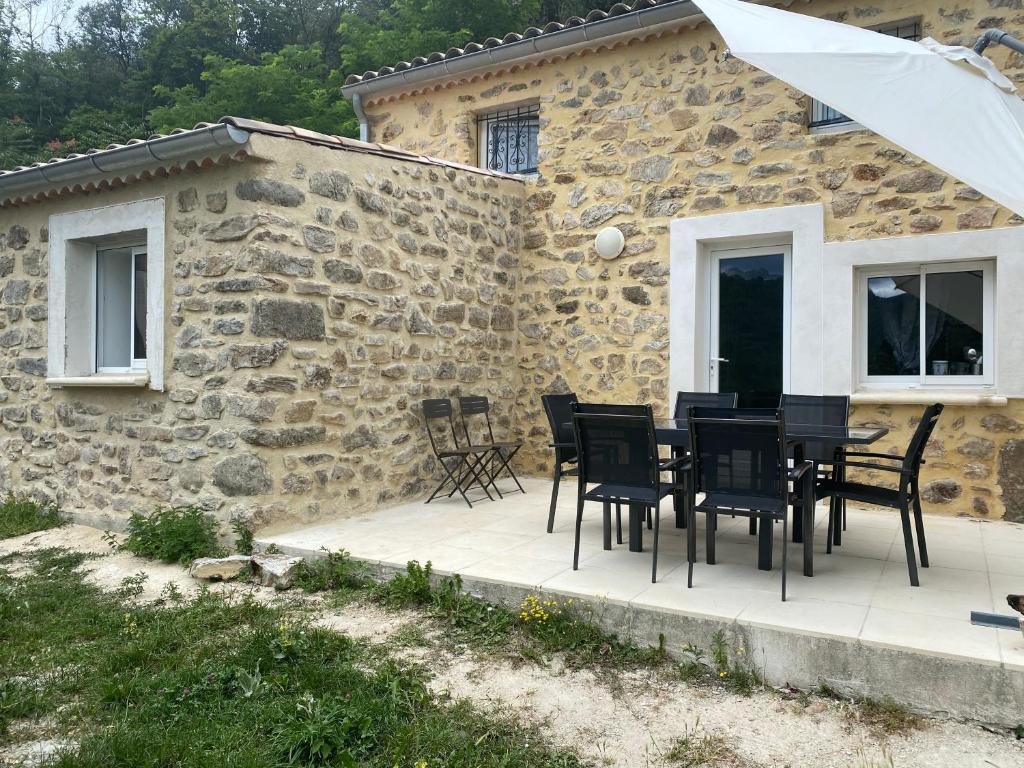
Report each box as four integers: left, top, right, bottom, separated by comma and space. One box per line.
344, 0, 1024, 520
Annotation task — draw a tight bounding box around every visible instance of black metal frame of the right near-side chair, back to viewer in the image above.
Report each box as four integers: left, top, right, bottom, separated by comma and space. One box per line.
686, 406, 815, 602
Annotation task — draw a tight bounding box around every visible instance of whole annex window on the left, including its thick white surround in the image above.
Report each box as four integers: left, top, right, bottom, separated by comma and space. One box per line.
46, 198, 165, 390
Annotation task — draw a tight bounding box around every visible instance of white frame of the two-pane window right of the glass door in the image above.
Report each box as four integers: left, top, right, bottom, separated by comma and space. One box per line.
855, 259, 997, 389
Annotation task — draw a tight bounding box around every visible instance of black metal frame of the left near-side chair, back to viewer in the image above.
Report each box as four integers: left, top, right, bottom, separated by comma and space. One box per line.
572, 403, 689, 582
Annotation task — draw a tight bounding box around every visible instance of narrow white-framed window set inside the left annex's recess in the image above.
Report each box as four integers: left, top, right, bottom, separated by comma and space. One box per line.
96, 246, 146, 373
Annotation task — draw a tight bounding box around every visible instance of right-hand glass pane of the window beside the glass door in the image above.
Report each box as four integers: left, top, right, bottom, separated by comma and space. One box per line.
925, 269, 985, 376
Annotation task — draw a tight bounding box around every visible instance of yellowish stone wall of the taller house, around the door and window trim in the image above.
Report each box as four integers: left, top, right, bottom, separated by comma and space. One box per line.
365, 0, 1024, 520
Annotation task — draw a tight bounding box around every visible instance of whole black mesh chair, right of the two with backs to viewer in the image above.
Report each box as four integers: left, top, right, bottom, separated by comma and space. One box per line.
686, 407, 814, 601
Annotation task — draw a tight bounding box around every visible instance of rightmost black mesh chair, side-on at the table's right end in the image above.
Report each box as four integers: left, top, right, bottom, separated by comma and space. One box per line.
815, 402, 943, 587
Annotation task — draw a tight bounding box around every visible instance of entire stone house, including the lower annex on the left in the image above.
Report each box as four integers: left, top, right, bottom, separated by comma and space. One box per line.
0, 0, 1024, 526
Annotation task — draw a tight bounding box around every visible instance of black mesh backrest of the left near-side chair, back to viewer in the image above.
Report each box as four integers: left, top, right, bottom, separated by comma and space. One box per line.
572, 403, 658, 492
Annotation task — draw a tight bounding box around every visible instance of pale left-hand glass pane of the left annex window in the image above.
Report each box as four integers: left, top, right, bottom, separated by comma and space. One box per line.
96, 248, 132, 368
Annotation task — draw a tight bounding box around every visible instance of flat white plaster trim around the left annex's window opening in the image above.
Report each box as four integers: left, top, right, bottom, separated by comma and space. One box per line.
47, 198, 165, 391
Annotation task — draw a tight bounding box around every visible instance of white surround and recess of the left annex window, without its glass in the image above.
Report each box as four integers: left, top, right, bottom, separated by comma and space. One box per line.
46, 198, 166, 391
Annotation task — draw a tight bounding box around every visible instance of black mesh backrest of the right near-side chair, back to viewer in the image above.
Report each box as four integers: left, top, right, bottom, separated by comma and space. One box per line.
688, 406, 788, 500
